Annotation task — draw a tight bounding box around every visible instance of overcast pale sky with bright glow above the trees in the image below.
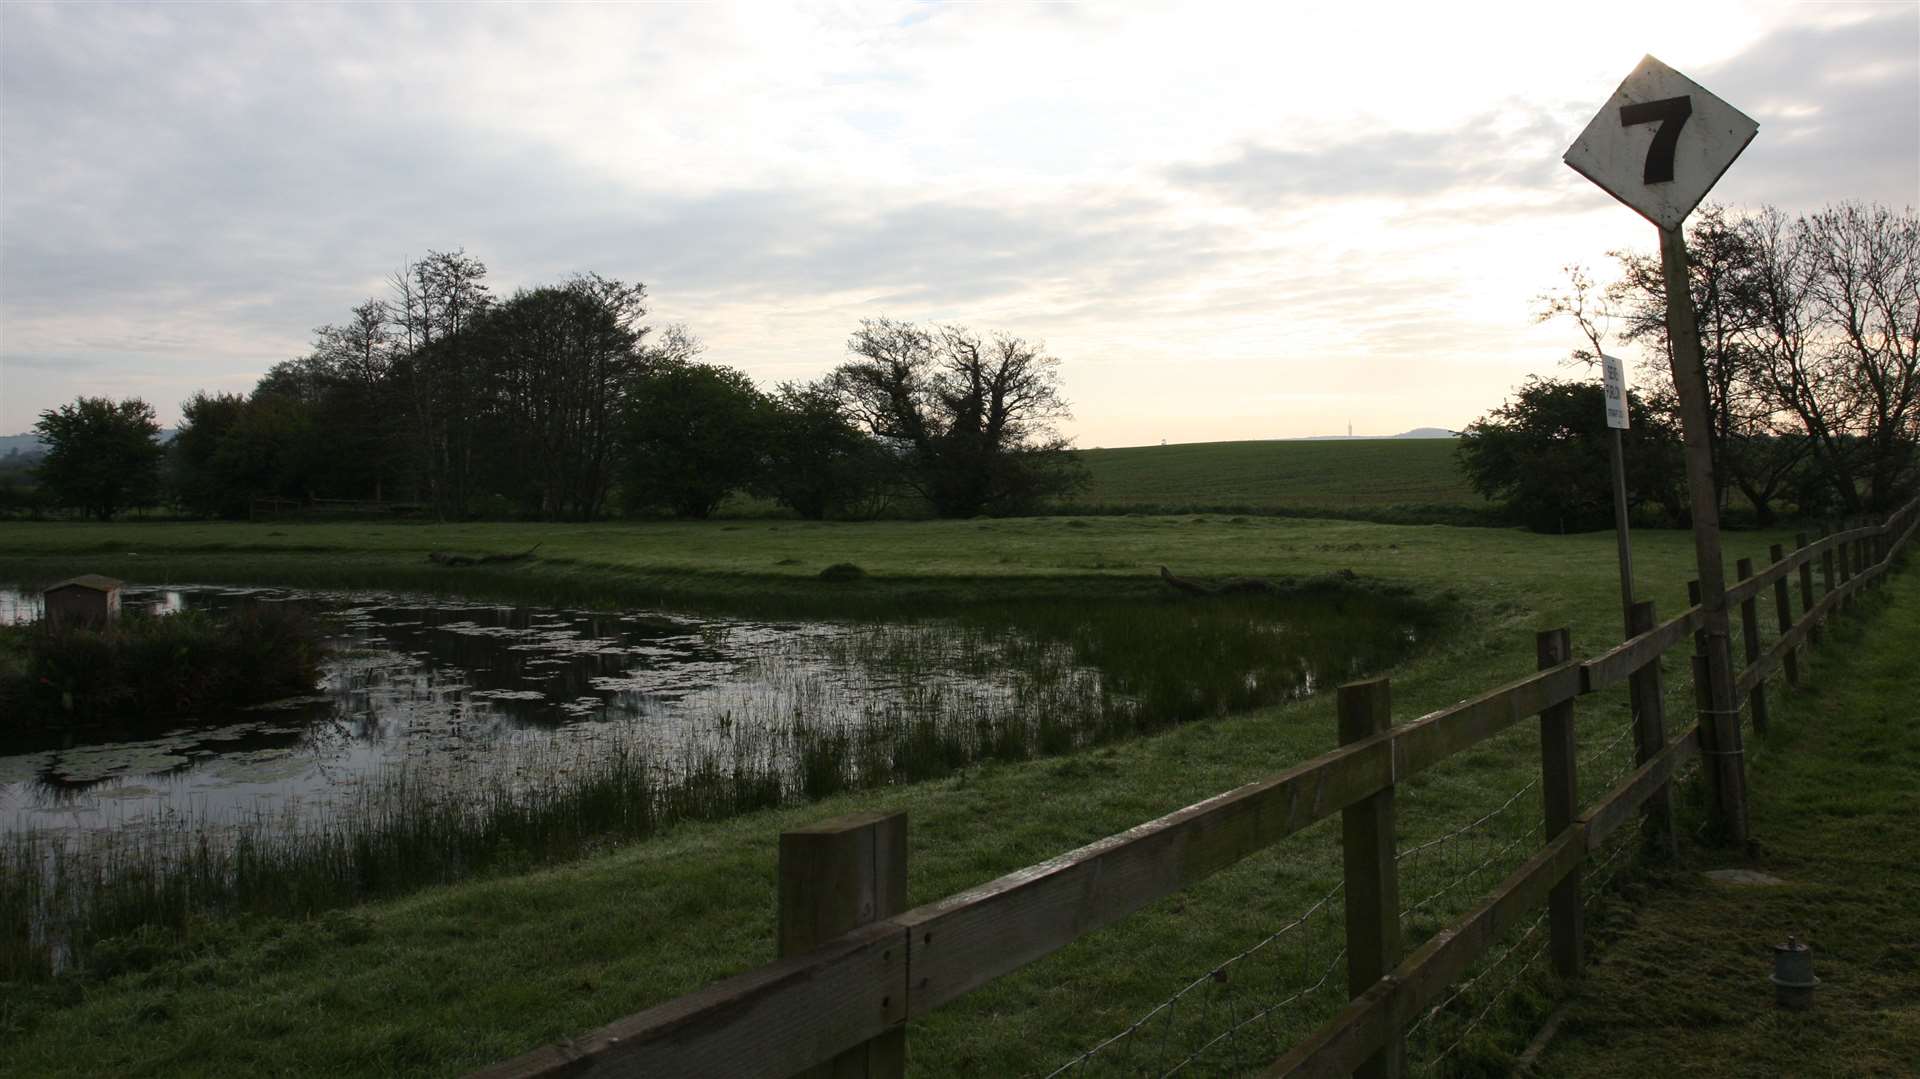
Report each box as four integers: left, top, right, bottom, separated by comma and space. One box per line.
0, 0, 1920, 445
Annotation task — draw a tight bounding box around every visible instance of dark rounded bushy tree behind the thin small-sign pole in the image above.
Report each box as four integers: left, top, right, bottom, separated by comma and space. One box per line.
1457, 378, 1684, 532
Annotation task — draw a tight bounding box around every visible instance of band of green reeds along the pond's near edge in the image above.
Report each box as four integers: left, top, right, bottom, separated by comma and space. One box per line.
0, 589, 1430, 981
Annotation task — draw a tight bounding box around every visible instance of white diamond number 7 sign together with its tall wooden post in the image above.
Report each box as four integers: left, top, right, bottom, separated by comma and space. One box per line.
1563, 56, 1759, 845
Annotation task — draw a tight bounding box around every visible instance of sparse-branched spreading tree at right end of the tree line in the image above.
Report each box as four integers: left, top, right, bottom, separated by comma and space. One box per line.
831, 319, 1085, 516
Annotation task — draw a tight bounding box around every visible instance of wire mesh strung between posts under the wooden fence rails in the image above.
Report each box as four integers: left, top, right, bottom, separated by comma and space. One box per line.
1035, 687, 1681, 1079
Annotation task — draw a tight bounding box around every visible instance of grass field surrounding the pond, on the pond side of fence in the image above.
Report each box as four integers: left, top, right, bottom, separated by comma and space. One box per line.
0, 506, 1889, 1075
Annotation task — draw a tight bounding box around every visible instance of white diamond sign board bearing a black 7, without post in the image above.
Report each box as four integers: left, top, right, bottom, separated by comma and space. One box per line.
1563, 56, 1761, 228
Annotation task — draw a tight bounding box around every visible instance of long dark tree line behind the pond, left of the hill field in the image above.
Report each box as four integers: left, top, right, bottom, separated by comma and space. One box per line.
22, 250, 1081, 520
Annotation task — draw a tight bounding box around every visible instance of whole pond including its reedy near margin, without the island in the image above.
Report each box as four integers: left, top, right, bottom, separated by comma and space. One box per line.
0, 586, 1428, 979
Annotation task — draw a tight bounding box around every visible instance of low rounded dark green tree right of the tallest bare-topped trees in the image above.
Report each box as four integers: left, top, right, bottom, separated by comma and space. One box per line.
626, 361, 768, 516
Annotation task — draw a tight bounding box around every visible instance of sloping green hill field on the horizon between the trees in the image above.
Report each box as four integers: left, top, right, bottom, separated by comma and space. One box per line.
1060, 438, 1496, 522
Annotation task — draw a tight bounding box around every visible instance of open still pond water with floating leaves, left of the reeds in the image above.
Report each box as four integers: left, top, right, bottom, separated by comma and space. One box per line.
0, 587, 1067, 831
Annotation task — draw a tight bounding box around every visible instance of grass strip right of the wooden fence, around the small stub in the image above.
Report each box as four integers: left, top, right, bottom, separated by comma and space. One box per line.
1538, 556, 1920, 1079
